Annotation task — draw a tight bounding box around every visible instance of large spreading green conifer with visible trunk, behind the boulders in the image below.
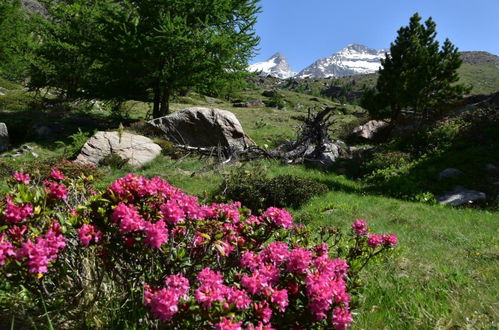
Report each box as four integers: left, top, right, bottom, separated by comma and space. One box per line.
32, 0, 259, 118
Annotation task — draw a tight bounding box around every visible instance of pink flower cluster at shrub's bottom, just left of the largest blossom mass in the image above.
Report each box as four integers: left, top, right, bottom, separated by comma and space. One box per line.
144, 275, 190, 322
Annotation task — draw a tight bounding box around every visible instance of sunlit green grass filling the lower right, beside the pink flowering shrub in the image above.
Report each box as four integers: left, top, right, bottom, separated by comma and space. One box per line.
295, 192, 499, 329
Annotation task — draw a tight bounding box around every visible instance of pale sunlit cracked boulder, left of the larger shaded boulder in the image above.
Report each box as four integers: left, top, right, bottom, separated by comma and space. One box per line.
76, 131, 161, 167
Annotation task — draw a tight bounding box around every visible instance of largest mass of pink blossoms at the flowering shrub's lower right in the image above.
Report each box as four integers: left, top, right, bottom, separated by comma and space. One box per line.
241, 242, 350, 323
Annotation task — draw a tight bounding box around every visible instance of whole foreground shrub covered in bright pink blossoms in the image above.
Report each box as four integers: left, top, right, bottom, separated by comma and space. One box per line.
0, 171, 397, 329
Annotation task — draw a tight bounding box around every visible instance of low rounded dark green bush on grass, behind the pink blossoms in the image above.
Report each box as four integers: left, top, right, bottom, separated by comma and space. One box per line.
218, 171, 328, 210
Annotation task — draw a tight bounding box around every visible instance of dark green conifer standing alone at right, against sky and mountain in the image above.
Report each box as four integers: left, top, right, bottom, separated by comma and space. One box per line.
363, 13, 468, 119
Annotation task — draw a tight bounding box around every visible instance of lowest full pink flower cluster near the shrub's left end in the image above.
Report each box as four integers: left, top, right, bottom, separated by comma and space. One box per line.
16, 222, 66, 273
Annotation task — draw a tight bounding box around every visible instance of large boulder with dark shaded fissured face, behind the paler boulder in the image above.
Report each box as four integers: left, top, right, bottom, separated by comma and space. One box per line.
149, 107, 254, 150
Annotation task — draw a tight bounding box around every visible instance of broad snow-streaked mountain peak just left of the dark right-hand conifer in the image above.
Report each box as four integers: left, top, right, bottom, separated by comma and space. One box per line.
296, 44, 387, 78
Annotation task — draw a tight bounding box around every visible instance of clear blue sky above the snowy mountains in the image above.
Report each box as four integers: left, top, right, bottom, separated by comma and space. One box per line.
250, 0, 499, 71
